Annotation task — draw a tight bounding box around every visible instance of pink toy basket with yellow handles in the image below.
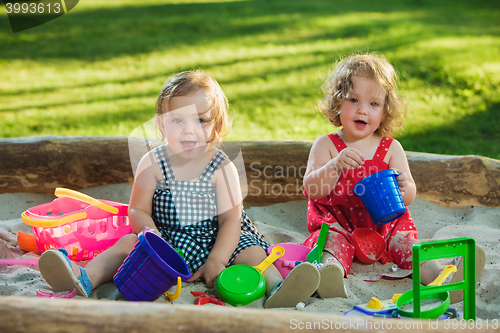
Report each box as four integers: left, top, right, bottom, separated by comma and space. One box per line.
21, 188, 132, 261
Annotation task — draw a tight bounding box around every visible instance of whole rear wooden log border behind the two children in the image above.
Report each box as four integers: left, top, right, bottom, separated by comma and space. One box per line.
0, 136, 500, 207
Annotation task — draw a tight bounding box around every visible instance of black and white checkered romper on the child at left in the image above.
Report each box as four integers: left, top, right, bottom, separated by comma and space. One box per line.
152, 145, 269, 273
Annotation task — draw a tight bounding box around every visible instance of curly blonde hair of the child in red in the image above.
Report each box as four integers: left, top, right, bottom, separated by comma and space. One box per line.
319, 54, 407, 136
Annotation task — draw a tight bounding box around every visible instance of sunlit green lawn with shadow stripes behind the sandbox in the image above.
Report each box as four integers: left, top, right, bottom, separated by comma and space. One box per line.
0, 0, 500, 158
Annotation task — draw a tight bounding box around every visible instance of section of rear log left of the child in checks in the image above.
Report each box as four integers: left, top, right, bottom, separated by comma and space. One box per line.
0, 136, 133, 194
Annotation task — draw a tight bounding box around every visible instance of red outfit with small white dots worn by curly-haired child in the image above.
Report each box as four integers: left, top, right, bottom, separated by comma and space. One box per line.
302, 133, 418, 275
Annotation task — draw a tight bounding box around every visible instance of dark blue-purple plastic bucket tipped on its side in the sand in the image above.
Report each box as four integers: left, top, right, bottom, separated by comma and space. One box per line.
113, 230, 191, 301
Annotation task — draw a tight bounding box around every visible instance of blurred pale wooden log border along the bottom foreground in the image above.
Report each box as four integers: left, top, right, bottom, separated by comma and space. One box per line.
0, 296, 498, 333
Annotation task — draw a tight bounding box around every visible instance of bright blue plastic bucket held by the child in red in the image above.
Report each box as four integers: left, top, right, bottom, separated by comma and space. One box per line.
353, 169, 406, 224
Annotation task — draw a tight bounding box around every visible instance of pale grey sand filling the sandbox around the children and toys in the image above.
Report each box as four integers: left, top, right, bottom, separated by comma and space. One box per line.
0, 185, 500, 319
